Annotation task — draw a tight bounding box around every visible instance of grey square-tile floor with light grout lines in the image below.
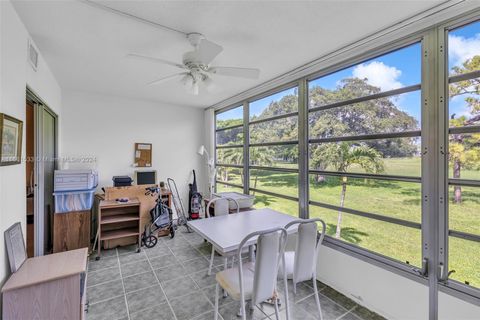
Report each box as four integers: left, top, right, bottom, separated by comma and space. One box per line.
87, 230, 383, 320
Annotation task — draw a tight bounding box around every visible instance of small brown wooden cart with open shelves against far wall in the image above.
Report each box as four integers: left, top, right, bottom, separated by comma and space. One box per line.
97, 198, 141, 258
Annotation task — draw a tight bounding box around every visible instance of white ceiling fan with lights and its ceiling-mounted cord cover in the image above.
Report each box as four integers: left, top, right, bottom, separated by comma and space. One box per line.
80, 0, 260, 95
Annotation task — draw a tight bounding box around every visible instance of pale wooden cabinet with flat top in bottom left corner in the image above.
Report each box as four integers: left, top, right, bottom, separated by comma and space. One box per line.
2, 248, 88, 320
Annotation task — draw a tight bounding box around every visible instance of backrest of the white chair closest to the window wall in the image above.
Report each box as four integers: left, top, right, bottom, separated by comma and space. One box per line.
285, 218, 326, 283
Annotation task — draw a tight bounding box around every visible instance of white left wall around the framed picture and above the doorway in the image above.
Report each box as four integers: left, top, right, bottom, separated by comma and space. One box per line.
0, 1, 61, 284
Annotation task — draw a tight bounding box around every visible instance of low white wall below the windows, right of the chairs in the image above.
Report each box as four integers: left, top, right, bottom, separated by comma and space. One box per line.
317, 246, 480, 320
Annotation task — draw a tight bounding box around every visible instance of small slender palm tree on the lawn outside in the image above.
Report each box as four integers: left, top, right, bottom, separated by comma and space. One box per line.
317, 142, 384, 238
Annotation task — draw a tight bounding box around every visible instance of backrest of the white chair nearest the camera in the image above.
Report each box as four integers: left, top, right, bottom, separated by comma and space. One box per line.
237, 228, 287, 304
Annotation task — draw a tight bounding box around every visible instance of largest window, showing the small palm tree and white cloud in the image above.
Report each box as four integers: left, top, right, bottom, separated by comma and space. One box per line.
308, 43, 421, 266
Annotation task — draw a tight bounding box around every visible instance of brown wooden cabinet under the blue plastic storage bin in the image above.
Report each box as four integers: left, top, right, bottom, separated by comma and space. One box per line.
53, 210, 91, 252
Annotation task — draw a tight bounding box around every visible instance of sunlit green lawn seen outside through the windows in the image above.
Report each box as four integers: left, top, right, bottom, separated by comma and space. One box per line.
218, 158, 480, 287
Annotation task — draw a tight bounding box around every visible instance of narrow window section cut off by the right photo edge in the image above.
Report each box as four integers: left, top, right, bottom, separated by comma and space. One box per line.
448, 22, 480, 288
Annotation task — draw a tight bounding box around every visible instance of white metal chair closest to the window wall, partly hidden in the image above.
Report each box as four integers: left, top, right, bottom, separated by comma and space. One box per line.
281, 218, 326, 319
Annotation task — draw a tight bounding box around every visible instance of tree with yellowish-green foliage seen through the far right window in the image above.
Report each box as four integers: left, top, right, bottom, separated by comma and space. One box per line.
448, 56, 480, 203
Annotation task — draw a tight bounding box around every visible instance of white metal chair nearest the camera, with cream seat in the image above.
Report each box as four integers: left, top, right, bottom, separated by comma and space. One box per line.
214, 228, 289, 320
